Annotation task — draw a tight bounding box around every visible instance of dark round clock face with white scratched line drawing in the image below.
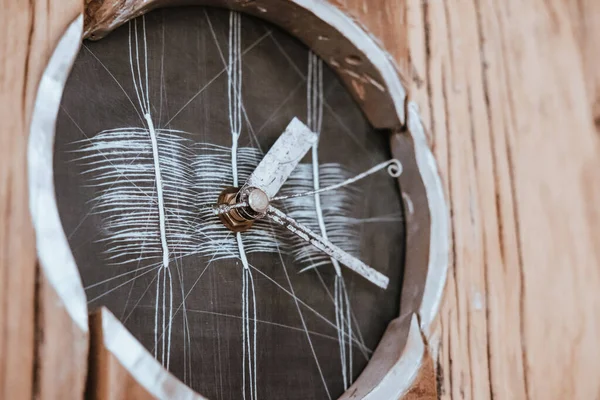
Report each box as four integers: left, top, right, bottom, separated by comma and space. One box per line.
54, 7, 404, 399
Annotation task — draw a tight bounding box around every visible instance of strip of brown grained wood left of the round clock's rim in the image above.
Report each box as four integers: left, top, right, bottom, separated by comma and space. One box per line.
0, 0, 85, 399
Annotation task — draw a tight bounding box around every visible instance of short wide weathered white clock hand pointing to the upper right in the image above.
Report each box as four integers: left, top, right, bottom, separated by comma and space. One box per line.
242, 118, 318, 200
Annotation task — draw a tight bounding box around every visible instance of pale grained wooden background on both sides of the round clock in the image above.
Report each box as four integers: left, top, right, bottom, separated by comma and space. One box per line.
0, 0, 600, 400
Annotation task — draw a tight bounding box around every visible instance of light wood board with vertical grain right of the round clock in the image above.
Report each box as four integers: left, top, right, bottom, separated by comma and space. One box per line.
398, 0, 600, 399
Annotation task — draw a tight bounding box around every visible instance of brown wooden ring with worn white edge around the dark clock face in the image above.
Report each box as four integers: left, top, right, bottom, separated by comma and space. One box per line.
28, 0, 449, 399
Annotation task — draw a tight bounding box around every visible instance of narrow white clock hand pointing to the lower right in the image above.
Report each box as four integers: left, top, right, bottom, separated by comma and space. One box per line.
267, 206, 389, 289
